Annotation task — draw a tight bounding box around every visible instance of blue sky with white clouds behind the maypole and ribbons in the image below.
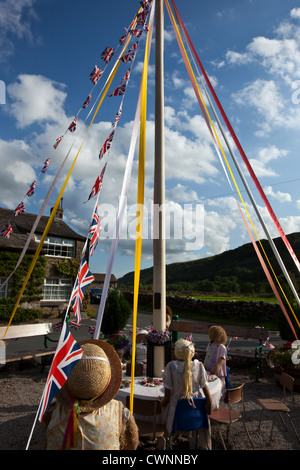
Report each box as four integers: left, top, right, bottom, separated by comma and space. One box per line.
0, 0, 300, 277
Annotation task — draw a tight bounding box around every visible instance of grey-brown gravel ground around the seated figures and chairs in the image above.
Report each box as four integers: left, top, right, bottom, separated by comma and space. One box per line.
0, 363, 300, 451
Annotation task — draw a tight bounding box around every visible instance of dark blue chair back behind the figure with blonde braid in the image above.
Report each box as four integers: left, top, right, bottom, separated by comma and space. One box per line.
173, 398, 208, 434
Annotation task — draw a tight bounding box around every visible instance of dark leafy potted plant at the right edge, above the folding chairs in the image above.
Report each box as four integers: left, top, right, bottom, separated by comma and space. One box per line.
267, 341, 300, 392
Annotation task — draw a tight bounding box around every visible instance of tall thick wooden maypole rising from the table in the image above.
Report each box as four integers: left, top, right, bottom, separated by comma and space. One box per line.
153, 0, 166, 377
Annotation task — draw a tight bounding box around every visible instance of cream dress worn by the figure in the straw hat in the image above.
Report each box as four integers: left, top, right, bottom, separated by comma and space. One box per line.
47, 400, 129, 450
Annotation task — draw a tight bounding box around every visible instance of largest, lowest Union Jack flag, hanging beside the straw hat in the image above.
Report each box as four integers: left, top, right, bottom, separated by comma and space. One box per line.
38, 322, 83, 421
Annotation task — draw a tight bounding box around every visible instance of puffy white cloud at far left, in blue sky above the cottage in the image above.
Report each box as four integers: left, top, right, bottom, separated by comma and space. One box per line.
7, 74, 67, 128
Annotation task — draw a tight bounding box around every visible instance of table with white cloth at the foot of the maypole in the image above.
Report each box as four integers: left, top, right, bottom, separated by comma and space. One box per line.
115, 373, 222, 410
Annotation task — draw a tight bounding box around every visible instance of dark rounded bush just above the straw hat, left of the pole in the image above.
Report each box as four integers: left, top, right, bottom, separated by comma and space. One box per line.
101, 290, 131, 336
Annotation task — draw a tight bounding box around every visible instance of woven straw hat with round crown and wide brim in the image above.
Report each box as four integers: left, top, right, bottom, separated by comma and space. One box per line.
56, 339, 122, 412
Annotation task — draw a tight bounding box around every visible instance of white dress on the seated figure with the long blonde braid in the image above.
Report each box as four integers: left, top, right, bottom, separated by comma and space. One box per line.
163, 359, 208, 434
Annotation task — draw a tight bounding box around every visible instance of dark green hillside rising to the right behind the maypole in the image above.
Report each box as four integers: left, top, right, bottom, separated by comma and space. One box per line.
118, 232, 300, 293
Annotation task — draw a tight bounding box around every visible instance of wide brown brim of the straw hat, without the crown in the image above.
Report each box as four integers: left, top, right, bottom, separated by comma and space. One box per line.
56, 339, 122, 412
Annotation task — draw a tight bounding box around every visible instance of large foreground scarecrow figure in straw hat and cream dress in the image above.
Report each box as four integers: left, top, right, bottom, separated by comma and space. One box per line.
43, 339, 139, 450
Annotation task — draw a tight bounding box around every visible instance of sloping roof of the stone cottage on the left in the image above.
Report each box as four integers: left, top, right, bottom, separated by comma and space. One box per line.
0, 207, 85, 251
